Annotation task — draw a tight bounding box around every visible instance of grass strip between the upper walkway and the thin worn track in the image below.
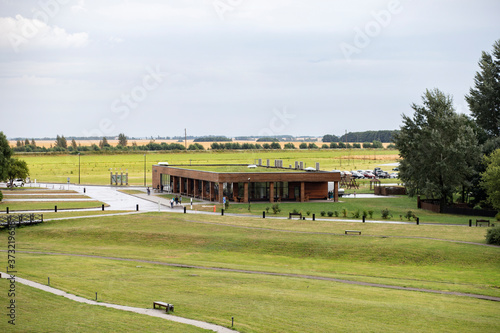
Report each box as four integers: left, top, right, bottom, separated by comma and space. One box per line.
11, 213, 500, 296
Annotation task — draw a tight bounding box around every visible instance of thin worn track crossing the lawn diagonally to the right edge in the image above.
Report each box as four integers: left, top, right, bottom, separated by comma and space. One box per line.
8, 251, 500, 304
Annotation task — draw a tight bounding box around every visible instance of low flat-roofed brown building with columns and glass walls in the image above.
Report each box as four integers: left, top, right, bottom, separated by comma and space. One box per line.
153, 164, 340, 202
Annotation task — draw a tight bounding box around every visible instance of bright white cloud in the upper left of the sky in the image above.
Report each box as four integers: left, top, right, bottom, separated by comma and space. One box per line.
0, 15, 89, 52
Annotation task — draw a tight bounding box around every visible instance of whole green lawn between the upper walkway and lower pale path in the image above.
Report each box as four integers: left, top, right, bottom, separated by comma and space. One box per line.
0, 213, 500, 332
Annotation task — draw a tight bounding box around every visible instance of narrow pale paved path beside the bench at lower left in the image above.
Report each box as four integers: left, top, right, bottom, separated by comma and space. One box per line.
0, 272, 237, 333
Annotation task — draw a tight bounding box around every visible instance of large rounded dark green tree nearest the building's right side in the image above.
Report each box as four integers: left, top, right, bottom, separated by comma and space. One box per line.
394, 89, 480, 207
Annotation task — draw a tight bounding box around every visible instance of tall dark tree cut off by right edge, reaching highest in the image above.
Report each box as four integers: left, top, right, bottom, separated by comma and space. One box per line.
465, 40, 500, 137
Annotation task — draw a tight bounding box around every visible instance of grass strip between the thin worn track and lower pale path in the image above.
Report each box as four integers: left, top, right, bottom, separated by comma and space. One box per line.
13, 254, 500, 332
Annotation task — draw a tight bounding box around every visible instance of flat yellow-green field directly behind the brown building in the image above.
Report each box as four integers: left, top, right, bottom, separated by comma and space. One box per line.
16, 149, 398, 185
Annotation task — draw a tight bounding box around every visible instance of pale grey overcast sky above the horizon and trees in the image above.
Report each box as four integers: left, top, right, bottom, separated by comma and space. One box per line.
0, 0, 500, 138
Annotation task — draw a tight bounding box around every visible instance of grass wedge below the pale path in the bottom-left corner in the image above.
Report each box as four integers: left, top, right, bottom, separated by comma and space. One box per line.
0, 279, 207, 333
